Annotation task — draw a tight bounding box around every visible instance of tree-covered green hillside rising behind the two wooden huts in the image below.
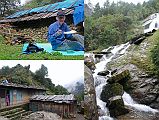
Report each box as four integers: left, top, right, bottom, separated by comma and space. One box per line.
0, 64, 69, 95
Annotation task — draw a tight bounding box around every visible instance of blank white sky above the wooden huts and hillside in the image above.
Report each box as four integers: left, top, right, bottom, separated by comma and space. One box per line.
0, 60, 84, 86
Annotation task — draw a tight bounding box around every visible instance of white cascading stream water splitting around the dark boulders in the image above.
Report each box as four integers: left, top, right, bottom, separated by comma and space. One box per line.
93, 43, 157, 120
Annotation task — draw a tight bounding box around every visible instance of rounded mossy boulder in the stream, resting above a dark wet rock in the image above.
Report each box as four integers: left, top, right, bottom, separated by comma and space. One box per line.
101, 83, 124, 102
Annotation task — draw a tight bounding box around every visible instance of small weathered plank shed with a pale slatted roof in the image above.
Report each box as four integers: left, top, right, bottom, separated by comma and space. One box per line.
29, 94, 77, 118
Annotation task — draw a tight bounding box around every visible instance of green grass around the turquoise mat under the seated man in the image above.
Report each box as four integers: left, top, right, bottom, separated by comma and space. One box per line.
0, 35, 84, 60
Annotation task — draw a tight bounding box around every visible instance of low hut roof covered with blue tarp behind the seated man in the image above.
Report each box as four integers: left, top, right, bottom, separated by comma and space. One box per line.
0, 0, 84, 28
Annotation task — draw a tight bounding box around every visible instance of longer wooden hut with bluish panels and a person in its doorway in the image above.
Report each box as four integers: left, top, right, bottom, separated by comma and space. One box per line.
0, 83, 46, 109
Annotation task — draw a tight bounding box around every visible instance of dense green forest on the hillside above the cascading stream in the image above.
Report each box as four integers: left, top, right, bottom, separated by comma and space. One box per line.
85, 0, 159, 51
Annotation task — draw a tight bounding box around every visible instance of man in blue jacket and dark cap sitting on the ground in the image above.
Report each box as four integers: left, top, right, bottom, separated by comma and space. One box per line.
48, 10, 84, 50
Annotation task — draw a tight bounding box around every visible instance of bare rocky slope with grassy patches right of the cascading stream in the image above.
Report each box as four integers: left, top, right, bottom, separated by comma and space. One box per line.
107, 31, 159, 109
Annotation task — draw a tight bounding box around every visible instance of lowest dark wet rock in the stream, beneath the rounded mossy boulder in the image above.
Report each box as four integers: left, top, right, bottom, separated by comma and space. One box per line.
107, 96, 129, 117
